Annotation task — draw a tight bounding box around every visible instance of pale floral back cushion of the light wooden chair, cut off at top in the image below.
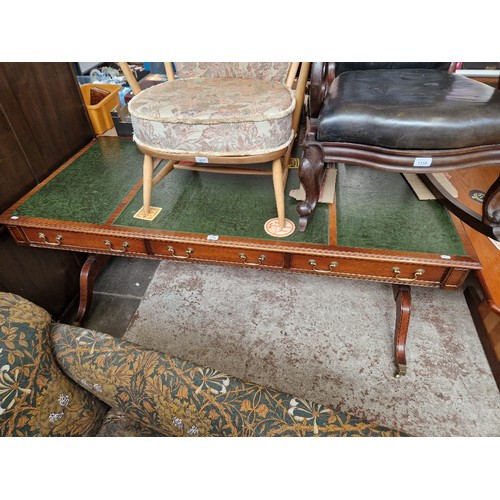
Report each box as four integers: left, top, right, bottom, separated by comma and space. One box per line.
175, 62, 291, 83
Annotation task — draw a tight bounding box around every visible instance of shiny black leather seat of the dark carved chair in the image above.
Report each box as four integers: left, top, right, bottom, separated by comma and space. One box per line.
317, 69, 500, 150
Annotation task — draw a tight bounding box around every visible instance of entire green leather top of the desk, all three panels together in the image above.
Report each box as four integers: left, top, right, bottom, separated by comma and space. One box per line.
7, 137, 466, 256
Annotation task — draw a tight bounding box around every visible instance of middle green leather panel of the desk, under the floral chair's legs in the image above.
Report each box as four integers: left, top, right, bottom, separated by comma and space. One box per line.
113, 167, 329, 245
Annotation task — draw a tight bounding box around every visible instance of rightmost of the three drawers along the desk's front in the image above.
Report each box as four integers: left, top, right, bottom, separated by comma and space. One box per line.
291, 255, 446, 285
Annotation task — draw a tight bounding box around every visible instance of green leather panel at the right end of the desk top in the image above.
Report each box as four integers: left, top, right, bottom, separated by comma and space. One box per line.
336, 165, 467, 256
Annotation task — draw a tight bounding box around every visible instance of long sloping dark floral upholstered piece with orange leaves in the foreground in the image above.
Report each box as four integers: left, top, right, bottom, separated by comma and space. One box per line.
51, 324, 403, 436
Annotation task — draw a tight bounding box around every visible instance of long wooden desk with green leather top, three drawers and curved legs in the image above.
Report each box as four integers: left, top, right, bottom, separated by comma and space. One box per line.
0, 137, 481, 375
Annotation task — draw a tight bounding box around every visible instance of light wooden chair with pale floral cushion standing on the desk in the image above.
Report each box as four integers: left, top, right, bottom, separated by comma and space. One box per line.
123, 63, 306, 234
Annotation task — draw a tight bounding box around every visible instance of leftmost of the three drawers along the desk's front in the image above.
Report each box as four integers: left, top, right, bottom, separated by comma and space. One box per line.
23, 228, 147, 255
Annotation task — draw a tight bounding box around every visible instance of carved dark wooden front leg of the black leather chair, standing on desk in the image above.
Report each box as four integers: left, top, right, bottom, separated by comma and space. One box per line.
297, 144, 325, 231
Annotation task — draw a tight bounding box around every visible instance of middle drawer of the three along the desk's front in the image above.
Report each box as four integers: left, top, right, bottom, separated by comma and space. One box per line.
150, 241, 285, 268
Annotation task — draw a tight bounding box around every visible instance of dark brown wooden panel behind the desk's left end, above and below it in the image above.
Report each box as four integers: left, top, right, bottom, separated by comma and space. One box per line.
0, 63, 94, 320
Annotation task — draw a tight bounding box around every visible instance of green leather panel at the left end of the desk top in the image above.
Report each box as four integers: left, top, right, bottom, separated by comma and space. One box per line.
13, 138, 144, 224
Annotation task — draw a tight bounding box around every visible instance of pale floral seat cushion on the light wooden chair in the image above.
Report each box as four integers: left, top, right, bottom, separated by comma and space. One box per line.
128, 78, 295, 156
